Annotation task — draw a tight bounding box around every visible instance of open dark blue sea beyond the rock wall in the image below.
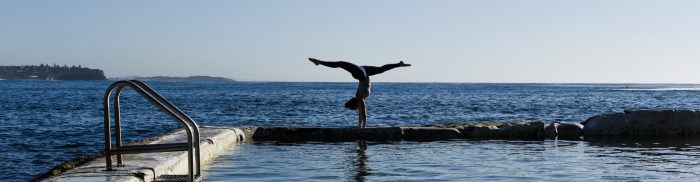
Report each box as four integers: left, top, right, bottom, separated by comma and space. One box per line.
0, 80, 700, 181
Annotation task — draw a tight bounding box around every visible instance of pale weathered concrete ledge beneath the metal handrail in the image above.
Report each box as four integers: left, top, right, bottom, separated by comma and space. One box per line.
38, 127, 245, 182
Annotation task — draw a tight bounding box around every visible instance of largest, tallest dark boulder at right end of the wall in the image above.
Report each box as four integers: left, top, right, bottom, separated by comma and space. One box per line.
581, 109, 700, 137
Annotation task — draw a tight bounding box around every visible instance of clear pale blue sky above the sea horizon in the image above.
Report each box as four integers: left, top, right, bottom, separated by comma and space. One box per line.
0, 0, 700, 83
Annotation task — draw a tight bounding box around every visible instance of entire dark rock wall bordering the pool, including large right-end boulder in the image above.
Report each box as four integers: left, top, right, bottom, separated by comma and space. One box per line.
248, 110, 700, 141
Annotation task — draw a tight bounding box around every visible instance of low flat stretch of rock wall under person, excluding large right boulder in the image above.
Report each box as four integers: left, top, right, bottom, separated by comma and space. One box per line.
245, 121, 583, 141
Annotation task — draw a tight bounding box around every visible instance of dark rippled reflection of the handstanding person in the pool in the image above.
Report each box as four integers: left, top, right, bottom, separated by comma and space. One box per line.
348, 140, 372, 182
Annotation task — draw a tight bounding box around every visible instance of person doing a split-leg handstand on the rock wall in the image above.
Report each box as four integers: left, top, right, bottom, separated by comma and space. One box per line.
309, 58, 411, 128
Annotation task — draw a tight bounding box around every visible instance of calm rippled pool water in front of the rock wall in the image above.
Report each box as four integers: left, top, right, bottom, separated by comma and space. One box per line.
204, 140, 700, 181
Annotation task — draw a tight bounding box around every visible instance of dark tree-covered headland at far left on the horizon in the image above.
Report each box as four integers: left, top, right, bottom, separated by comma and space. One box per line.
0, 64, 107, 80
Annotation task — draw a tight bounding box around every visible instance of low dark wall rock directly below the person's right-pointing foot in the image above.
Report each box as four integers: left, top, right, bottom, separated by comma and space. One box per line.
401, 127, 460, 141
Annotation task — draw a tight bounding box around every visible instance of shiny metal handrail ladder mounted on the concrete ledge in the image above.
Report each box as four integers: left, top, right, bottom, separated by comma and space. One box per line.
103, 80, 202, 182
